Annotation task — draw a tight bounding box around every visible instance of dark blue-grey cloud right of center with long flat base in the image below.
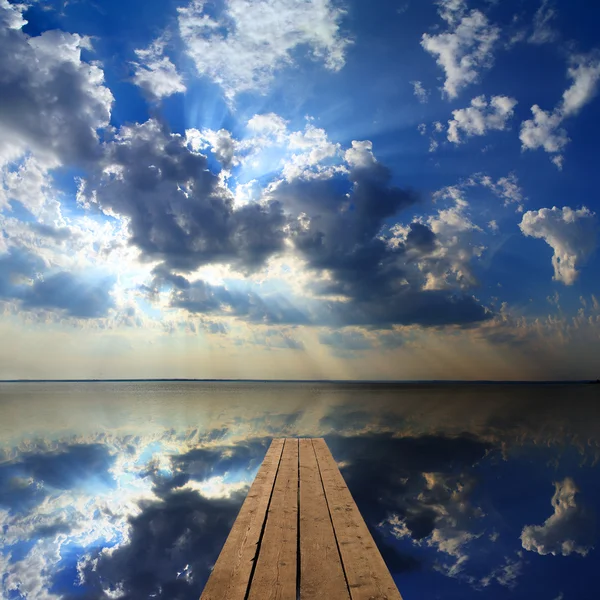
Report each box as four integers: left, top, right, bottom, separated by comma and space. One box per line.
273, 162, 491, 327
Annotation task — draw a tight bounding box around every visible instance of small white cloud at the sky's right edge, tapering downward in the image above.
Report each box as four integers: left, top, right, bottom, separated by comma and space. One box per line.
519, 206, 597, 285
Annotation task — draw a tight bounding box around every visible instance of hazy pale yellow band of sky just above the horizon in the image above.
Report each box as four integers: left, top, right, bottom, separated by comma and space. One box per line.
0, 322, 597, 380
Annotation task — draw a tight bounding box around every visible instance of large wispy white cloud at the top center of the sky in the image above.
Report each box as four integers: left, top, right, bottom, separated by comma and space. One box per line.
178, 0, 349, 100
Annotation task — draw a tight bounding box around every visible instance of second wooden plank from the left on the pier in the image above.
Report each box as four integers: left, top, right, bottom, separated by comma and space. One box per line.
248, 438, 298, 600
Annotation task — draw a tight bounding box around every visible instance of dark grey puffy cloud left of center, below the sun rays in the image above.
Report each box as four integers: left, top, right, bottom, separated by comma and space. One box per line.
84, 120, 286, 277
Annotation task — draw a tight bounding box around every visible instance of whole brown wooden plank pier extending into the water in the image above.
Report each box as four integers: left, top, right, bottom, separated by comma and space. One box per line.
201, 438, 401, 600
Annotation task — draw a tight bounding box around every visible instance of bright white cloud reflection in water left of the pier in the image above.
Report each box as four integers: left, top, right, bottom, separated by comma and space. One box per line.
0, 436, 260, 600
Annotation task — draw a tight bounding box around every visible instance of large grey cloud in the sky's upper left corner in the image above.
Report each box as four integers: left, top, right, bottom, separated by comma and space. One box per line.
0, 3, 113, 164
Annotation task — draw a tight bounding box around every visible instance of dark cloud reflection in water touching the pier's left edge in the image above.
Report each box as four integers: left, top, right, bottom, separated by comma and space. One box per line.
75, 491, 243, 600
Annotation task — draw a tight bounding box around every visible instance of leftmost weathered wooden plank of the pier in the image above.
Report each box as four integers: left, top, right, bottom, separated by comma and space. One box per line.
200, 439, 284, 600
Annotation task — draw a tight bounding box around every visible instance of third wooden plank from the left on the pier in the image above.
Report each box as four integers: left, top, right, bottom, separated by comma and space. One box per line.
299, 439, 350, 600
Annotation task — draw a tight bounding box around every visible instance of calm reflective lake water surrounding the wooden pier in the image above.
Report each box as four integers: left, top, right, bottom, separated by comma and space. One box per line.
0, 382, 600, 600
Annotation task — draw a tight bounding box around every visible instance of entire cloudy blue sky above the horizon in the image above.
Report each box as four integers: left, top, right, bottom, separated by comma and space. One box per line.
0, 0, 600, 380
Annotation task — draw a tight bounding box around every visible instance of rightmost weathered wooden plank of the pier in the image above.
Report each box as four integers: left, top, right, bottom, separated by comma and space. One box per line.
313, 438, 401, 600
